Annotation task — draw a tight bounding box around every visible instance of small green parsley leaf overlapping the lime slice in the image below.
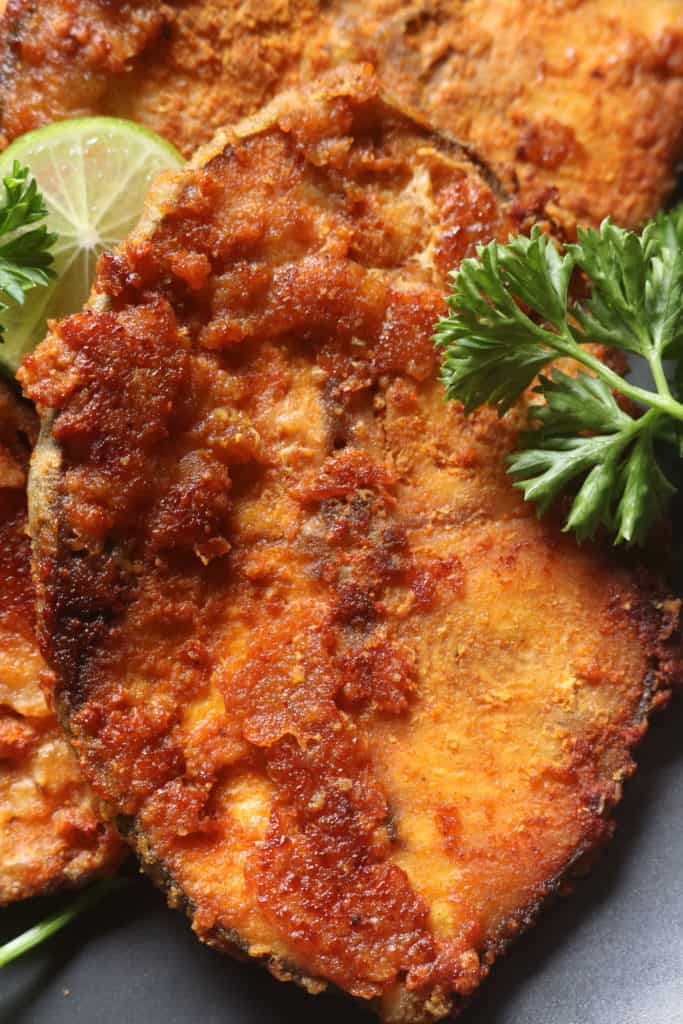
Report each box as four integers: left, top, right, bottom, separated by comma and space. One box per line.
0, 160, 56, 337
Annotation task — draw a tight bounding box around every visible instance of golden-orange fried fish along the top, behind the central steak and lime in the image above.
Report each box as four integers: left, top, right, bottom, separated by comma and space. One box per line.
0, 0, 683, 234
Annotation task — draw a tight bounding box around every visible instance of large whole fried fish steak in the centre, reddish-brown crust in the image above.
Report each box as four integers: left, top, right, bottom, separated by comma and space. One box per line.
20, 66, 679, 1024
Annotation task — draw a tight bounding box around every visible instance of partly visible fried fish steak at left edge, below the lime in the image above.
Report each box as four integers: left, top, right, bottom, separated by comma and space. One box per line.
0, 382, 122, 905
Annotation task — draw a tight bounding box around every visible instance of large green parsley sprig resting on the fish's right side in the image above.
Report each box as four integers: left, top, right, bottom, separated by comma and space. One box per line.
435, 207, 683, 544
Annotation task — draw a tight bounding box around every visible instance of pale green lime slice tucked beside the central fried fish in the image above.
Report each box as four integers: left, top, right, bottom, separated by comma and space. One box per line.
0, 118, 183, 373
